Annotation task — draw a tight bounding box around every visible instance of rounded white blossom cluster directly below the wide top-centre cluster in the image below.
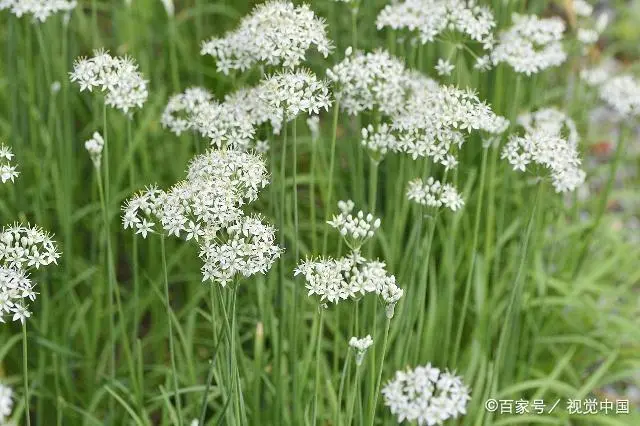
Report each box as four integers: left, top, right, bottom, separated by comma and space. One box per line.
261, 69, 331, 121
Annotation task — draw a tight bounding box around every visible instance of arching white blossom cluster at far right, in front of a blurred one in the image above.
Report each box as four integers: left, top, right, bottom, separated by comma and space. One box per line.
501, 131, 586, 192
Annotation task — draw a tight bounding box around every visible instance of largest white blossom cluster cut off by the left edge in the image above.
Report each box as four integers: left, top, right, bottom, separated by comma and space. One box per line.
0, 224, 60, 322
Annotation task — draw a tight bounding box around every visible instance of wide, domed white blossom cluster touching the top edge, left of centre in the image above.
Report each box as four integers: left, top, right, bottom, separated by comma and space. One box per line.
200, 0, 332, 74
